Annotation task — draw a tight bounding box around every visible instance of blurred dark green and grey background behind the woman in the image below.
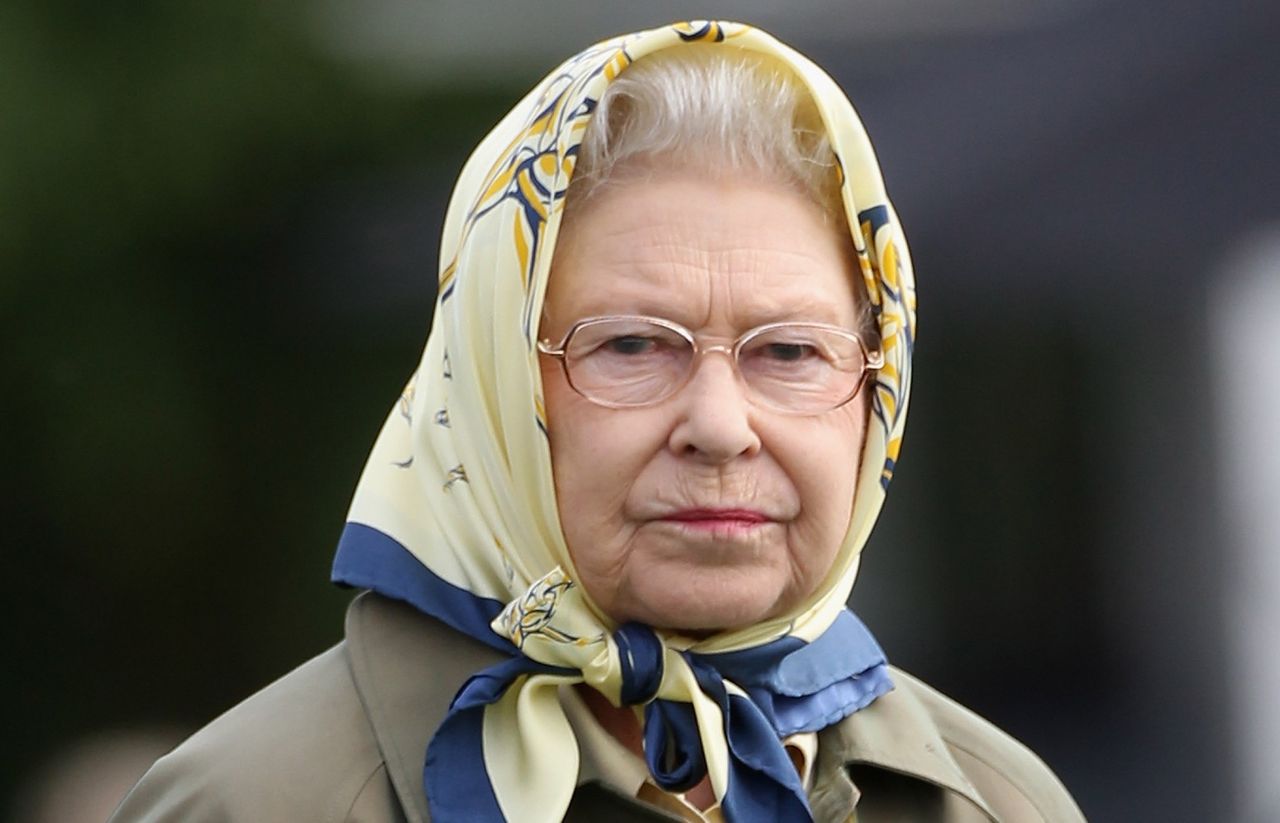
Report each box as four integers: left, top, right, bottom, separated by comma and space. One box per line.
0, 0, 1280, 820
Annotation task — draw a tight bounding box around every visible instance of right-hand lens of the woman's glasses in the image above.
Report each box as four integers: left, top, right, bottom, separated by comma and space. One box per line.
737, 324, 867, 412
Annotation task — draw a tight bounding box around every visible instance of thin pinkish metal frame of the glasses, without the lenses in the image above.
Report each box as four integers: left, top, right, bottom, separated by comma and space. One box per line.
538, 315, 884, 416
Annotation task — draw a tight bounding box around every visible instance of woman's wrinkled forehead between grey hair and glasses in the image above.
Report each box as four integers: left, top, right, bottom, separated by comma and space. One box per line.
544, 173, 856, 330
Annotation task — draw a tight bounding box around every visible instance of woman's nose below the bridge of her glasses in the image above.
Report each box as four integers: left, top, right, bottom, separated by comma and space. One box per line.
668, 349, 760, 463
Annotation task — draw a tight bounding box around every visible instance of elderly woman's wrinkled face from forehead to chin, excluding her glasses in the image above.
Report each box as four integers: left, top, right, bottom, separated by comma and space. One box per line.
541, 174, 867, 632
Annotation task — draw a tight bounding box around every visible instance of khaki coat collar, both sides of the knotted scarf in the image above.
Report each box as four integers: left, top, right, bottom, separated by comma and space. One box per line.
346, 593, 995, 823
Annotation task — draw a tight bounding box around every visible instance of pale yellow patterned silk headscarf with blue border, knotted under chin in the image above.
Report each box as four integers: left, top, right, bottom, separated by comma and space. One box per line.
333, 22, 915, 820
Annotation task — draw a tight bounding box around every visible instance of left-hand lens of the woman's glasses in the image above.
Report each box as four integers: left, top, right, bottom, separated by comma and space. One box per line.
564, 320, 694, 406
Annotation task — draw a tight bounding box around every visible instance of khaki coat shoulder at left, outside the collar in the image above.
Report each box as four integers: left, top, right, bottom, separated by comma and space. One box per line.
111, 644, 403, 823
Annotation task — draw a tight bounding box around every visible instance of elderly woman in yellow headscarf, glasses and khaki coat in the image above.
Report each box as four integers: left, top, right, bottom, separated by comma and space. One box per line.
114, 23, 1080, 823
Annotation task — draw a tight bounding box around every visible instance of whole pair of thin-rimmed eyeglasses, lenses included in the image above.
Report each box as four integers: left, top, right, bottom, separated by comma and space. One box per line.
538, 315, 884, 415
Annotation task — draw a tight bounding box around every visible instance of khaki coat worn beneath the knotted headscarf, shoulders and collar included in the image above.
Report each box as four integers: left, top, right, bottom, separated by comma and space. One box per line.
110, 593, 1084, 823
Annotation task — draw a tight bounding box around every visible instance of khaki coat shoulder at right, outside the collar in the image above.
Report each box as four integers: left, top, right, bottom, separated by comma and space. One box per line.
893, 669, 1084, 823
